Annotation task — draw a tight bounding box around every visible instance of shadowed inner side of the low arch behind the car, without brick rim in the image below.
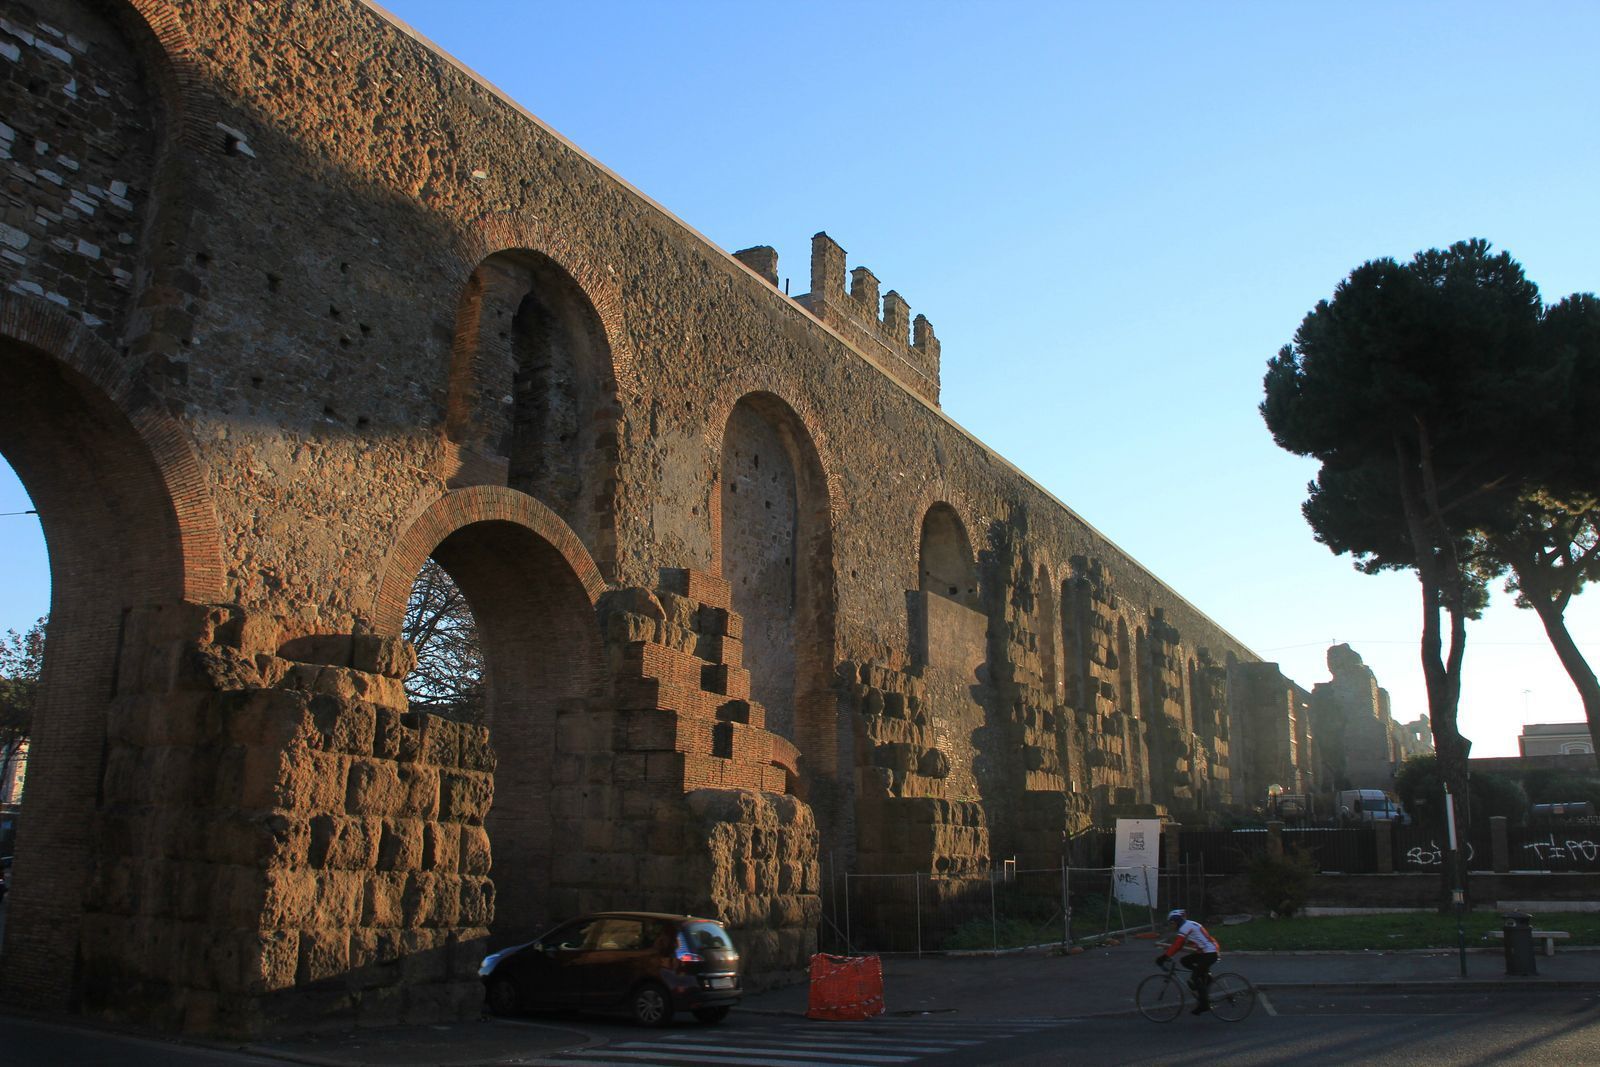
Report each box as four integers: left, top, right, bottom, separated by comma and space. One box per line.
406, 520, 610, 945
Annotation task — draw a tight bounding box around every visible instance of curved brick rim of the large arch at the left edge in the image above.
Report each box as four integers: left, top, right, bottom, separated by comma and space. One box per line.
0, 293, 227, 603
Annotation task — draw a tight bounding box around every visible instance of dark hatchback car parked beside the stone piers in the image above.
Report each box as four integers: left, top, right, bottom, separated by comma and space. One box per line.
478, 912, 742, 1025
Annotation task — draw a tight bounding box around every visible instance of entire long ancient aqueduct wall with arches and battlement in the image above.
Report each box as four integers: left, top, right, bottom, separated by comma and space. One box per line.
0, 0, 1294, 1032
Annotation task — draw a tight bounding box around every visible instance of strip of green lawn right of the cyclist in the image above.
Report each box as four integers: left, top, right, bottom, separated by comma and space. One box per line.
1206, 912, 1600, 953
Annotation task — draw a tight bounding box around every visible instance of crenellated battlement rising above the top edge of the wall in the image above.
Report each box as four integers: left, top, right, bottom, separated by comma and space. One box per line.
733, 234, 939, 403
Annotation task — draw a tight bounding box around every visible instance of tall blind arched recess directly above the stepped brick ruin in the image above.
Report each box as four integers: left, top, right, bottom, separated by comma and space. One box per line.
717, 394, 838, 783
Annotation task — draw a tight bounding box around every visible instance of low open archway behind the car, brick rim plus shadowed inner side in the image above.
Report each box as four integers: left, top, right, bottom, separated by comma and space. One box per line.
376, 486, 605, 945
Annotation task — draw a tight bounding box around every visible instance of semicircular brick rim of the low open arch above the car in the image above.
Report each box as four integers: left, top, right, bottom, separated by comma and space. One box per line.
371, 485, 606, 637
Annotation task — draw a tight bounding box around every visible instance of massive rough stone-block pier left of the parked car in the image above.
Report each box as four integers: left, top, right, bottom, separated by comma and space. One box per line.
78, 605, 494, 1035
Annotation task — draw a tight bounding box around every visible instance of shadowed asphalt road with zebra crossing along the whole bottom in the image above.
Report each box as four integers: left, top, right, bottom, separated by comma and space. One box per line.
0, 985, 1600, 1067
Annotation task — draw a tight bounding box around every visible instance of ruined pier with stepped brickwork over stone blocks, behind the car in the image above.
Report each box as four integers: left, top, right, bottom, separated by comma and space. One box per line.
585, 569, 821, 989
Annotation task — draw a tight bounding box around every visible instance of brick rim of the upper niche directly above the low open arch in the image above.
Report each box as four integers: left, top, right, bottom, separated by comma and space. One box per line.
442, 213, 638, 396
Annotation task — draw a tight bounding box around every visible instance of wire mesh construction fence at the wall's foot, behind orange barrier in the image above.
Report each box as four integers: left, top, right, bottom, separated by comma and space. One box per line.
822, 862, 1198, 955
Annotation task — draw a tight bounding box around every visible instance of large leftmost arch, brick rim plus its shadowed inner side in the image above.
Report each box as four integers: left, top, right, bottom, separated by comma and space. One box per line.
0, 294, 222, 1006
